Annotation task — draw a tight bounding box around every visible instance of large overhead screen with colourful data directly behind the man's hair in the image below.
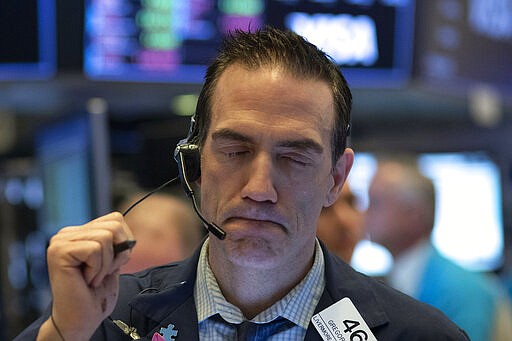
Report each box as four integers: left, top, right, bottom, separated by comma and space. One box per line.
84, 0, 414, 86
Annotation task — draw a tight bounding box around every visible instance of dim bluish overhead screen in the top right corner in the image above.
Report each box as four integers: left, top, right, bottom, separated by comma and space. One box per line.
416, 0, 512, 95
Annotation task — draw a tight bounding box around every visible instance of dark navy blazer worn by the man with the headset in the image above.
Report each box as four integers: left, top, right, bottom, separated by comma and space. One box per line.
15, 240, 468, 341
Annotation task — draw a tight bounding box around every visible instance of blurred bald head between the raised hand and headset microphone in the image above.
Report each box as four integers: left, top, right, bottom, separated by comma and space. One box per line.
119, 192, 206, 273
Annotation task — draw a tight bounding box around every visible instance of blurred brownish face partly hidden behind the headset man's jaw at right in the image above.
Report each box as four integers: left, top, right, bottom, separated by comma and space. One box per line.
317, 182, 363, 264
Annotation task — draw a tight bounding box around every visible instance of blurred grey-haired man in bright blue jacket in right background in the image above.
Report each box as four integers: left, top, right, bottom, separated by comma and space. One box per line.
365, 155, 512, 341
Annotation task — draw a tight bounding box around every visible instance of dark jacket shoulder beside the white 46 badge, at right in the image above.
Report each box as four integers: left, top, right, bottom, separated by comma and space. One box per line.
322, 247, 468, 340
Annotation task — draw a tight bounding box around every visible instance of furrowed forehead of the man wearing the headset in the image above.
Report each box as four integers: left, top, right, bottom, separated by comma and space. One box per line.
211, 64, 334, 137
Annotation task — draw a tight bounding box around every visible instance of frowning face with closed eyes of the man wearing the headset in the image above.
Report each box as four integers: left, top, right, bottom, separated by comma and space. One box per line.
200, 65, 353, 268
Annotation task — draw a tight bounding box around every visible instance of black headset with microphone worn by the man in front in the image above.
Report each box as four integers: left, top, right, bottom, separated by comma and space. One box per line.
174, 116, 226, 240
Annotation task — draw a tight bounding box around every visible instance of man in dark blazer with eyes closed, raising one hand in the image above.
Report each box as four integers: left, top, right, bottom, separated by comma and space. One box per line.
16, 28, 466, 340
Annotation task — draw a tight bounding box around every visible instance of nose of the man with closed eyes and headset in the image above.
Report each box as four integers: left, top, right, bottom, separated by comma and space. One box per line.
242, 153, 277, 203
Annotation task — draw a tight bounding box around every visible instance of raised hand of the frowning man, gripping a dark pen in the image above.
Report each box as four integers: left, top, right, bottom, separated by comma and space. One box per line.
38, 212, 133, 340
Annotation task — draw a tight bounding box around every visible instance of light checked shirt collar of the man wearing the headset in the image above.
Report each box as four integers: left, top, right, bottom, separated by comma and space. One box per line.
194, 236, 325, 329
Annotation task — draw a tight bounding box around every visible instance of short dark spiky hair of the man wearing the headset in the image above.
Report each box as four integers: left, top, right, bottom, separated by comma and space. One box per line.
191, 26, 352, 164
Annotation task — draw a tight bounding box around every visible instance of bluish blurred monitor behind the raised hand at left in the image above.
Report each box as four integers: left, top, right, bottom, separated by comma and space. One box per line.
34, 113, 111, 235
